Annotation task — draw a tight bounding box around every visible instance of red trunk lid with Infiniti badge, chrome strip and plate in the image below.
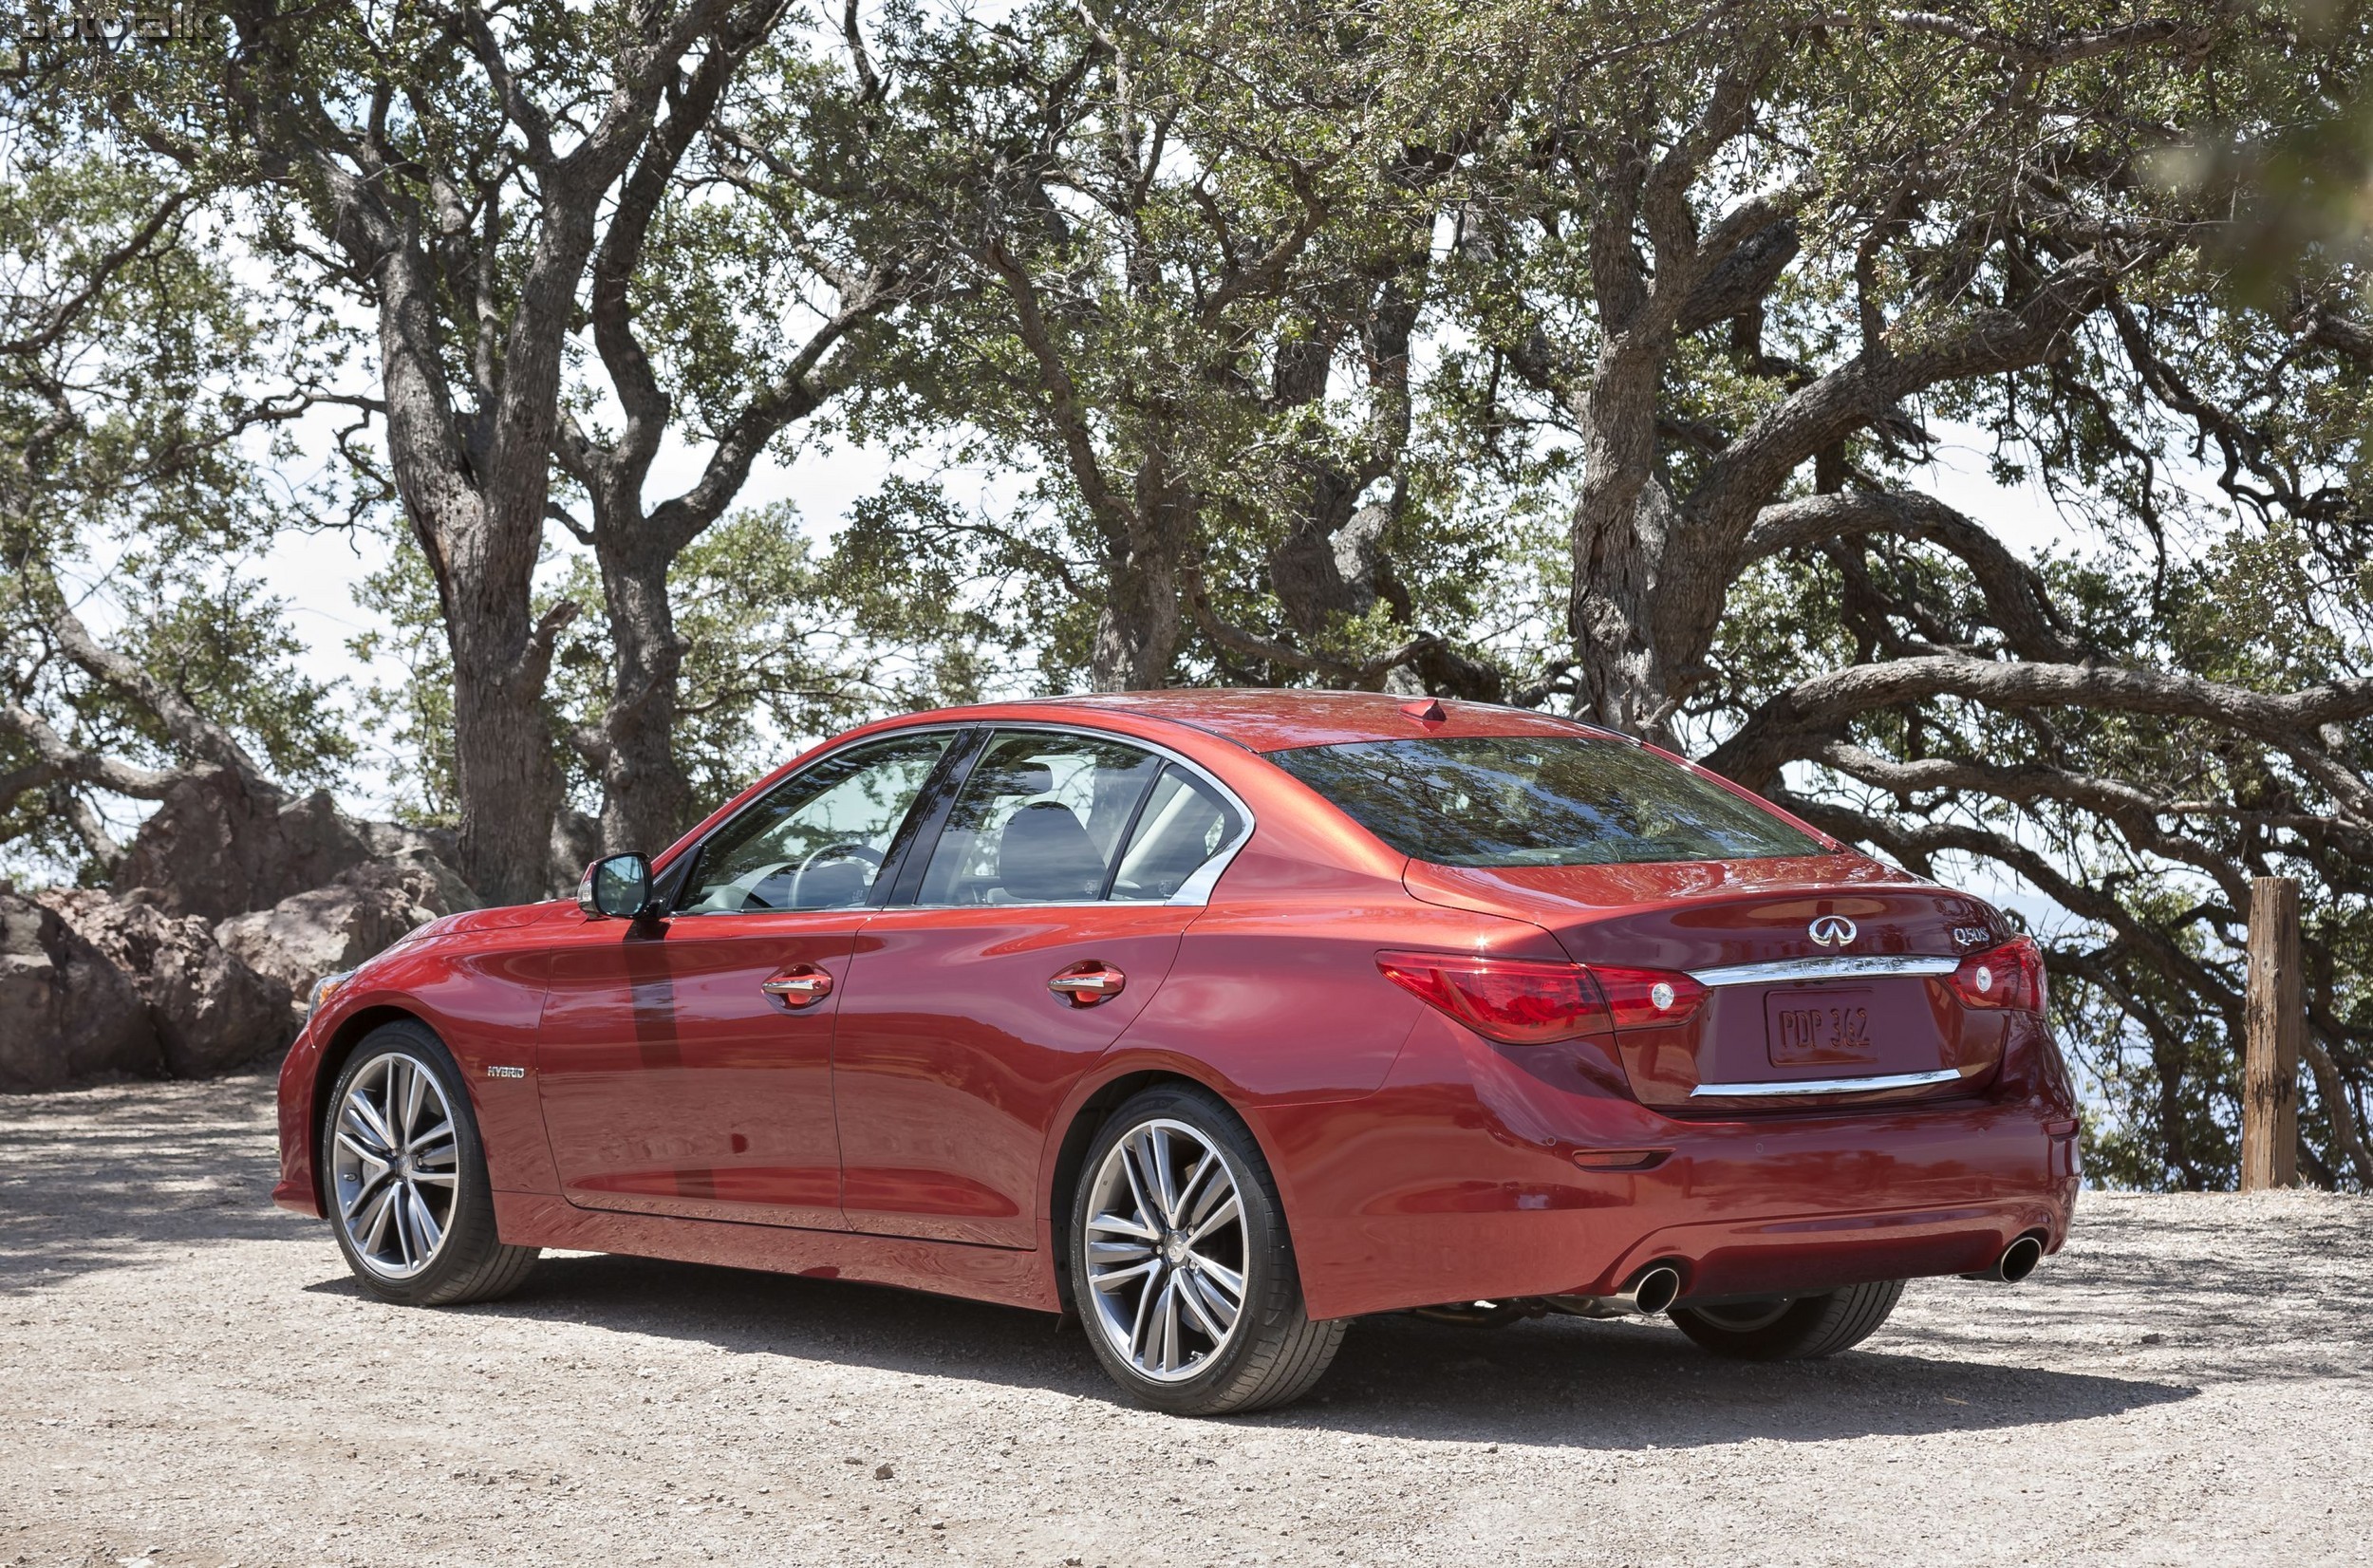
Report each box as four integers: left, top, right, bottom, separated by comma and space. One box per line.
1405, 854, 2012, 1115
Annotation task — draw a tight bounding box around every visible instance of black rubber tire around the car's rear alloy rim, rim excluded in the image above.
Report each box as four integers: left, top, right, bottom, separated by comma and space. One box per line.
1068, 1084, 1346, 1416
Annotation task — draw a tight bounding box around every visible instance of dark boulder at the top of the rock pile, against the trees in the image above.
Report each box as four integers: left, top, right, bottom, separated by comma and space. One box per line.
117, 769, 373, 921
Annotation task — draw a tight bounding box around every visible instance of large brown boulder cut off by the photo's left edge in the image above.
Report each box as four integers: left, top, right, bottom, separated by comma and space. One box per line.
0, 889, 161, 1089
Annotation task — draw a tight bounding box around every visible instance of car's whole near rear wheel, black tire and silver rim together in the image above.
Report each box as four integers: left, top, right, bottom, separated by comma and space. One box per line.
1071, 1087, 1343, 1416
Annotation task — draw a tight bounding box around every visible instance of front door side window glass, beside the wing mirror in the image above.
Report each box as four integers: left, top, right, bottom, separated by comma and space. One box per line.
677, 731, 954, 916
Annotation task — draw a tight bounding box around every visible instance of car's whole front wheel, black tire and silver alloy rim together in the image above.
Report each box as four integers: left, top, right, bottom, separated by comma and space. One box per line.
321, 1022, 541, 1307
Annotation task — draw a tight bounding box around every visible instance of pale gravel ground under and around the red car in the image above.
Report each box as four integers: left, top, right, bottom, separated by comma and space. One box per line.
0, 1077, 2373, 1568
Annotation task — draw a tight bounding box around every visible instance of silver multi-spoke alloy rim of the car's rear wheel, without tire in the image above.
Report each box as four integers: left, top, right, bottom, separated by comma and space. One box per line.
1085, 1120, 1246, 1383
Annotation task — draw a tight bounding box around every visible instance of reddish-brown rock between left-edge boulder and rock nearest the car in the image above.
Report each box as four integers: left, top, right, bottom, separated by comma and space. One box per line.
38, 889, 294, 1077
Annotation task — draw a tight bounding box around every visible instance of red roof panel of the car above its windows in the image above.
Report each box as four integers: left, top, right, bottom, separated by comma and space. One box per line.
1006, 685, 1616, 752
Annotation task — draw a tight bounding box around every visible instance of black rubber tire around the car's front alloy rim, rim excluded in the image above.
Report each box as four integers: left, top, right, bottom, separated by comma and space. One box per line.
321, 1020, 544, 1307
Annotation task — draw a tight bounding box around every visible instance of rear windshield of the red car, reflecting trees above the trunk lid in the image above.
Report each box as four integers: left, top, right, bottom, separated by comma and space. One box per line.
1270, 736, 1822, 866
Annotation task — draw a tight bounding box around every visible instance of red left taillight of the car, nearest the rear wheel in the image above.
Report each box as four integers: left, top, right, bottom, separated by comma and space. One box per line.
1376, 954, 1707, 1046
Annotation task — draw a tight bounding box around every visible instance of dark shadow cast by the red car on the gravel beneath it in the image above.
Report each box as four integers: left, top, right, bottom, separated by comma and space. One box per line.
308, 1255, 2197, 1449
